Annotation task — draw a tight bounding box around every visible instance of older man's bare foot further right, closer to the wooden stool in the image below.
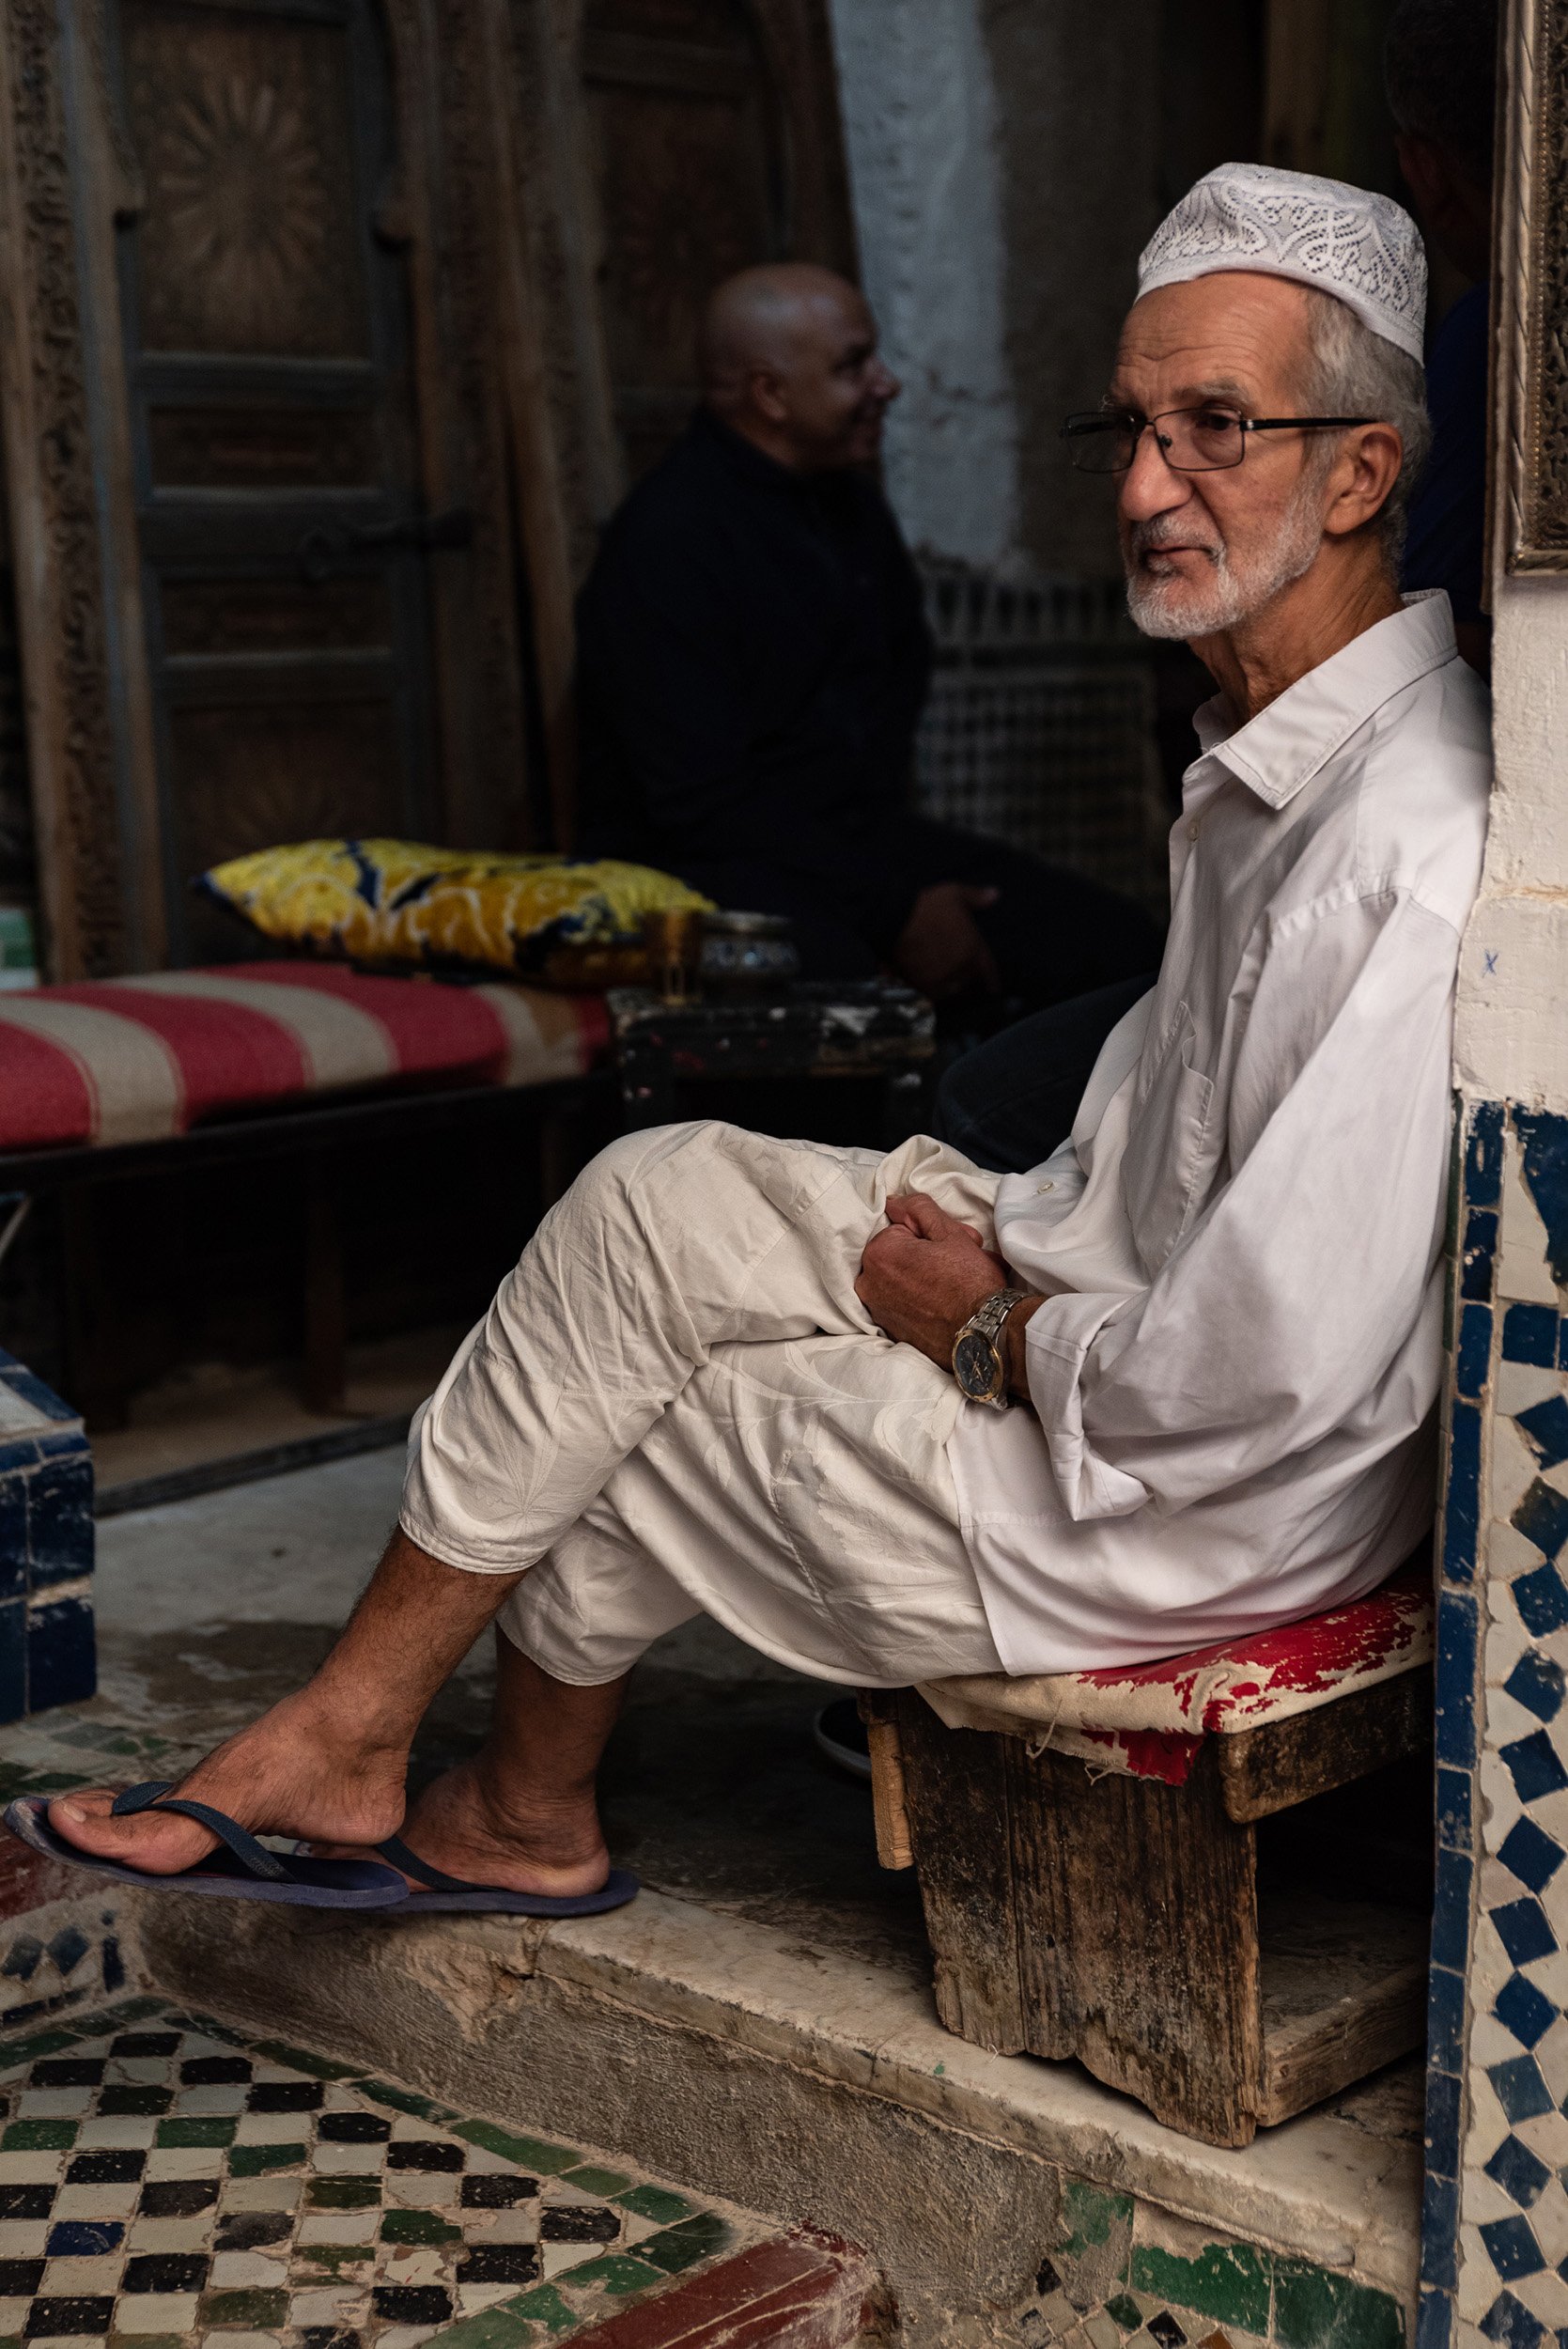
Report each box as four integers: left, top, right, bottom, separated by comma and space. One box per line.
312, 1748, 611, 1898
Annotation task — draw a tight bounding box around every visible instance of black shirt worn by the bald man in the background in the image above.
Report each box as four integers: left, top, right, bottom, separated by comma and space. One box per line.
578, 409, 932, 954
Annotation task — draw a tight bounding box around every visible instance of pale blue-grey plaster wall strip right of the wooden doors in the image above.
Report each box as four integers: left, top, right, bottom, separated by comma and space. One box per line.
831, 0, 1018, 564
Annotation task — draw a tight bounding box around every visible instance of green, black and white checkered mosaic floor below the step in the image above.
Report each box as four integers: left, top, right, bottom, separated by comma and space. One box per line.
0, 1999, 768, 2349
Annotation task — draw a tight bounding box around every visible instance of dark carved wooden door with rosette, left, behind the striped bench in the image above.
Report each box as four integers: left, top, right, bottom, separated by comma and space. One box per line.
113, 0, 445, 963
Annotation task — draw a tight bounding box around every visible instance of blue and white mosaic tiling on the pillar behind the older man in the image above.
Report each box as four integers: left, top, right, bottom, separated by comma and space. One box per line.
1418, 1102, 1568, 2349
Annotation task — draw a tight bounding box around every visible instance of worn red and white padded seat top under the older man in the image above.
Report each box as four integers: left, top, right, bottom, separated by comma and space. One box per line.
920, 1555, 1435, 1785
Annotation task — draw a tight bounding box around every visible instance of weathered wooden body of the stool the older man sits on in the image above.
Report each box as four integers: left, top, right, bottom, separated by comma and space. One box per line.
862, 1668, 1432, 2145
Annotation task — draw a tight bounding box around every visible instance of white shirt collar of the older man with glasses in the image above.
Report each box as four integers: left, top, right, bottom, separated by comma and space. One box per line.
1192, 587, 1458, 808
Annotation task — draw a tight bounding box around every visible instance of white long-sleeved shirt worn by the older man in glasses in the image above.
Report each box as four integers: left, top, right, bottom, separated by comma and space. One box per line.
948, 592, 1491, 1672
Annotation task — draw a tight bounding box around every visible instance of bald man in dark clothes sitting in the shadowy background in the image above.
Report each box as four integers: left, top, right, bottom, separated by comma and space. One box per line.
578, 263, 1159, 1024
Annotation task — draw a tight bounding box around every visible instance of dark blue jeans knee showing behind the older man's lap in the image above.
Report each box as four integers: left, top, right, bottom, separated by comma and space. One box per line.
934, 971, 1157, 1174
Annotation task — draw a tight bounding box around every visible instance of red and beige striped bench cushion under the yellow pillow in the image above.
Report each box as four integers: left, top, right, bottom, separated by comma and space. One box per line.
0, 961, 608, 1151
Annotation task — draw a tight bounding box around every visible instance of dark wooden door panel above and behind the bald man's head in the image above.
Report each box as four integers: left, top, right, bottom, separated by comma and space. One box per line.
582, 0, 854, 477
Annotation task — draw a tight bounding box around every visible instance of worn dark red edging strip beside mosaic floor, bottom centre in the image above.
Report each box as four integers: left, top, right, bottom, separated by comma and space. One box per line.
570, 2227, 880, 2349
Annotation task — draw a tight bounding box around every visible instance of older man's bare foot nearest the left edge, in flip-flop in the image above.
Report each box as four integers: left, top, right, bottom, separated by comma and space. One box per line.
49, 1689, 409, 1877
